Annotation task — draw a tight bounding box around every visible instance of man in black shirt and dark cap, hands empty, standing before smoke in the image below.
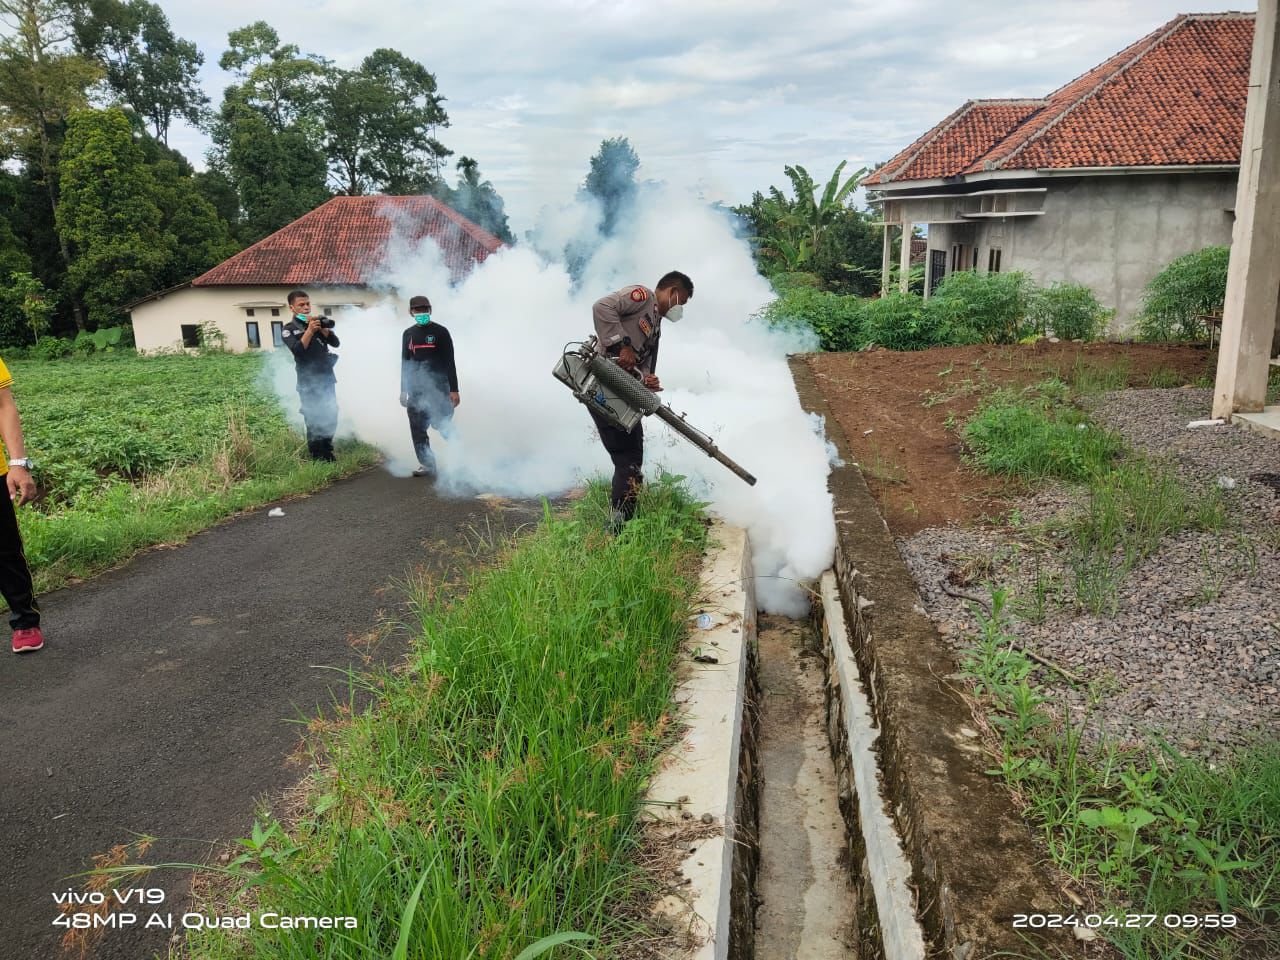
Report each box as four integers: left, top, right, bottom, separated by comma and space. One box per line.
401, 296, 458, 476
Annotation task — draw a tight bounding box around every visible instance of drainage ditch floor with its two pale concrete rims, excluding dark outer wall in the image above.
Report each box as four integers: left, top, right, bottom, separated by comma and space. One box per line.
645, 525, 925, 960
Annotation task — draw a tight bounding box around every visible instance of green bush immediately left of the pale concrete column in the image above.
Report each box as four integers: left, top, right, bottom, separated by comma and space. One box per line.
1138, 247, 1231, 340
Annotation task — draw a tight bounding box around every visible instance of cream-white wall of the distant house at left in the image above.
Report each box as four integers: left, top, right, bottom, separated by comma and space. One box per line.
129, 287, 383, 353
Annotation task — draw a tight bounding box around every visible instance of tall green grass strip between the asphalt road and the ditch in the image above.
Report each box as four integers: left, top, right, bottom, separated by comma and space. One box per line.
157, 483, 705, 960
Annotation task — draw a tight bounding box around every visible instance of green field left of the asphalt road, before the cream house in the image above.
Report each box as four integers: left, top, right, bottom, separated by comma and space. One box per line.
9, 355, 376, 593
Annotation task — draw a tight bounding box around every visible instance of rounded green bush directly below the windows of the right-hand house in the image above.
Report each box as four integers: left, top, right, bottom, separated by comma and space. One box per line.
929, 270, 1034, 343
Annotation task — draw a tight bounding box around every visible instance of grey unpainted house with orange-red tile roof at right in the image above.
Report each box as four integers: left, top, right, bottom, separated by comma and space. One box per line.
863, 13, 1254, 329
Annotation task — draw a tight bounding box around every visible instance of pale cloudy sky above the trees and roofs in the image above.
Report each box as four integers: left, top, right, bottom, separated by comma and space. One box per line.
160, 0, 1256, 234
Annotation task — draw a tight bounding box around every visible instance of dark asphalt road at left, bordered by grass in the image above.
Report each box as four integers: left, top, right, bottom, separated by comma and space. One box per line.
0, 470, 538, 960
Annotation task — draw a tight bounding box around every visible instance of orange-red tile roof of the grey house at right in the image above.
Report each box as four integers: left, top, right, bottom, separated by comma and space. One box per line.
864, 13, 1253, 186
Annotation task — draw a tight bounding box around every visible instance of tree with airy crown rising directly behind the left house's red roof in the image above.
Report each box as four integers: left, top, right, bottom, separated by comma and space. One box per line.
321, 47, 453, 196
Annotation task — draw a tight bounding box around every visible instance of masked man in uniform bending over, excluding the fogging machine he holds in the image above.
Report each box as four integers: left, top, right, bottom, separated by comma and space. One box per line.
588, 270, 694, 527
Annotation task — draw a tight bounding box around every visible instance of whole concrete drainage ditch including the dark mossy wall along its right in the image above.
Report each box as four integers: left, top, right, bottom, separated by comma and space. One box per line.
646, 366, 1088, 960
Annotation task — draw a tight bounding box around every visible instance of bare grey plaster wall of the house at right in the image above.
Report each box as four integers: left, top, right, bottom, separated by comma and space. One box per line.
901, 173, 1236, 333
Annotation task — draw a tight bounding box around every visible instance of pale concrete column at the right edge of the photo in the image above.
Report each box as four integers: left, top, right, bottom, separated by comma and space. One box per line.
1213, 0, 1280, 417
